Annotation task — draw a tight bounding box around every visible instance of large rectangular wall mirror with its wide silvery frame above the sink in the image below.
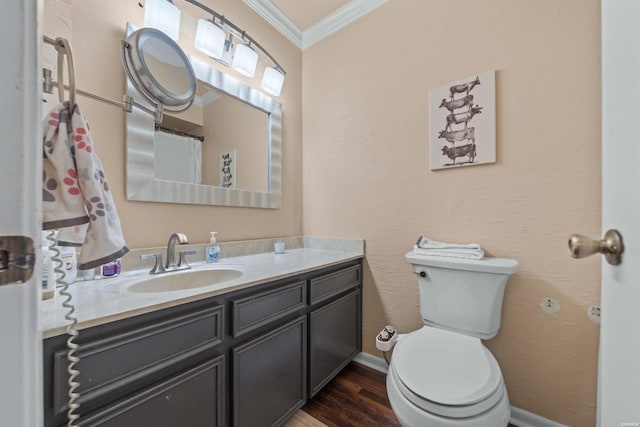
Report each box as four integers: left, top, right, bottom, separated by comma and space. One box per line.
126, 26, 282, 208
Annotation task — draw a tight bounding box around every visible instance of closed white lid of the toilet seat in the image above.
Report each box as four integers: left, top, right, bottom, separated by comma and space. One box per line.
393, 326, 502, 405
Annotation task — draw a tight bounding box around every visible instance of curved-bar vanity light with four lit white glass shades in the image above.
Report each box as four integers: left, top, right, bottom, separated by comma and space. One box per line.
144, 0, 286, 96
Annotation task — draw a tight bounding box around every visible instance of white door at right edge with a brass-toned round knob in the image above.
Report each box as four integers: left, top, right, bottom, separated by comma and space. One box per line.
594, 0, 640, 427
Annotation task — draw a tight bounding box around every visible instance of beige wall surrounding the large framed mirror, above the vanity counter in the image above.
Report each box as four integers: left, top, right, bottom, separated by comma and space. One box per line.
43, 0, 302, 247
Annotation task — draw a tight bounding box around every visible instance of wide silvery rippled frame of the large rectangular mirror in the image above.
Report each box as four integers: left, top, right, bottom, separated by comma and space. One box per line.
126, 25, 282, 209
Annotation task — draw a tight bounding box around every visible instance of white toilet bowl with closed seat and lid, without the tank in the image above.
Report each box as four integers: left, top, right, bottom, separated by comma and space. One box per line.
387, 326, 511, 427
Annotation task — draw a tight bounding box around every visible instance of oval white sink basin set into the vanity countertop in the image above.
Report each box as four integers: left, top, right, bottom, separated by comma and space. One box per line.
127, 266, 244, 293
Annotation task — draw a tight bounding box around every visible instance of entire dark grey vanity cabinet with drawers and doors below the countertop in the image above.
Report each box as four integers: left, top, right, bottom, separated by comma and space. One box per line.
43, 260, 362, 427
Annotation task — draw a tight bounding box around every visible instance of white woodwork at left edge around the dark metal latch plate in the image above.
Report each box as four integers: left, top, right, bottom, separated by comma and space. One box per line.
0, 0, 42, 427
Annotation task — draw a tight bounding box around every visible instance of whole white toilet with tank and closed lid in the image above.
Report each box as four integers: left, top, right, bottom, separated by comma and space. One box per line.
387, 252, 518, 427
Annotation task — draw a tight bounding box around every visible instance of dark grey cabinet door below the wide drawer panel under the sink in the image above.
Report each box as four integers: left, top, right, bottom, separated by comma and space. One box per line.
81, 356, 225, 427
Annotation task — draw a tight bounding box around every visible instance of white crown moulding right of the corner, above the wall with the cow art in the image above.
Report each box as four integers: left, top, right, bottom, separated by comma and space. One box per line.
302, 0, 389, 50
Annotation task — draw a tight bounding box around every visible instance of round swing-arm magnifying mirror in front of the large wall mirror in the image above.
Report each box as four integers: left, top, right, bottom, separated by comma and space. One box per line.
122, 28, 196, 112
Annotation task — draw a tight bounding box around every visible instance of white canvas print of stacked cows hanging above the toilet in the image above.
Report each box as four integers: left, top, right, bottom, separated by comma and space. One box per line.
429, 71, 496, 170
